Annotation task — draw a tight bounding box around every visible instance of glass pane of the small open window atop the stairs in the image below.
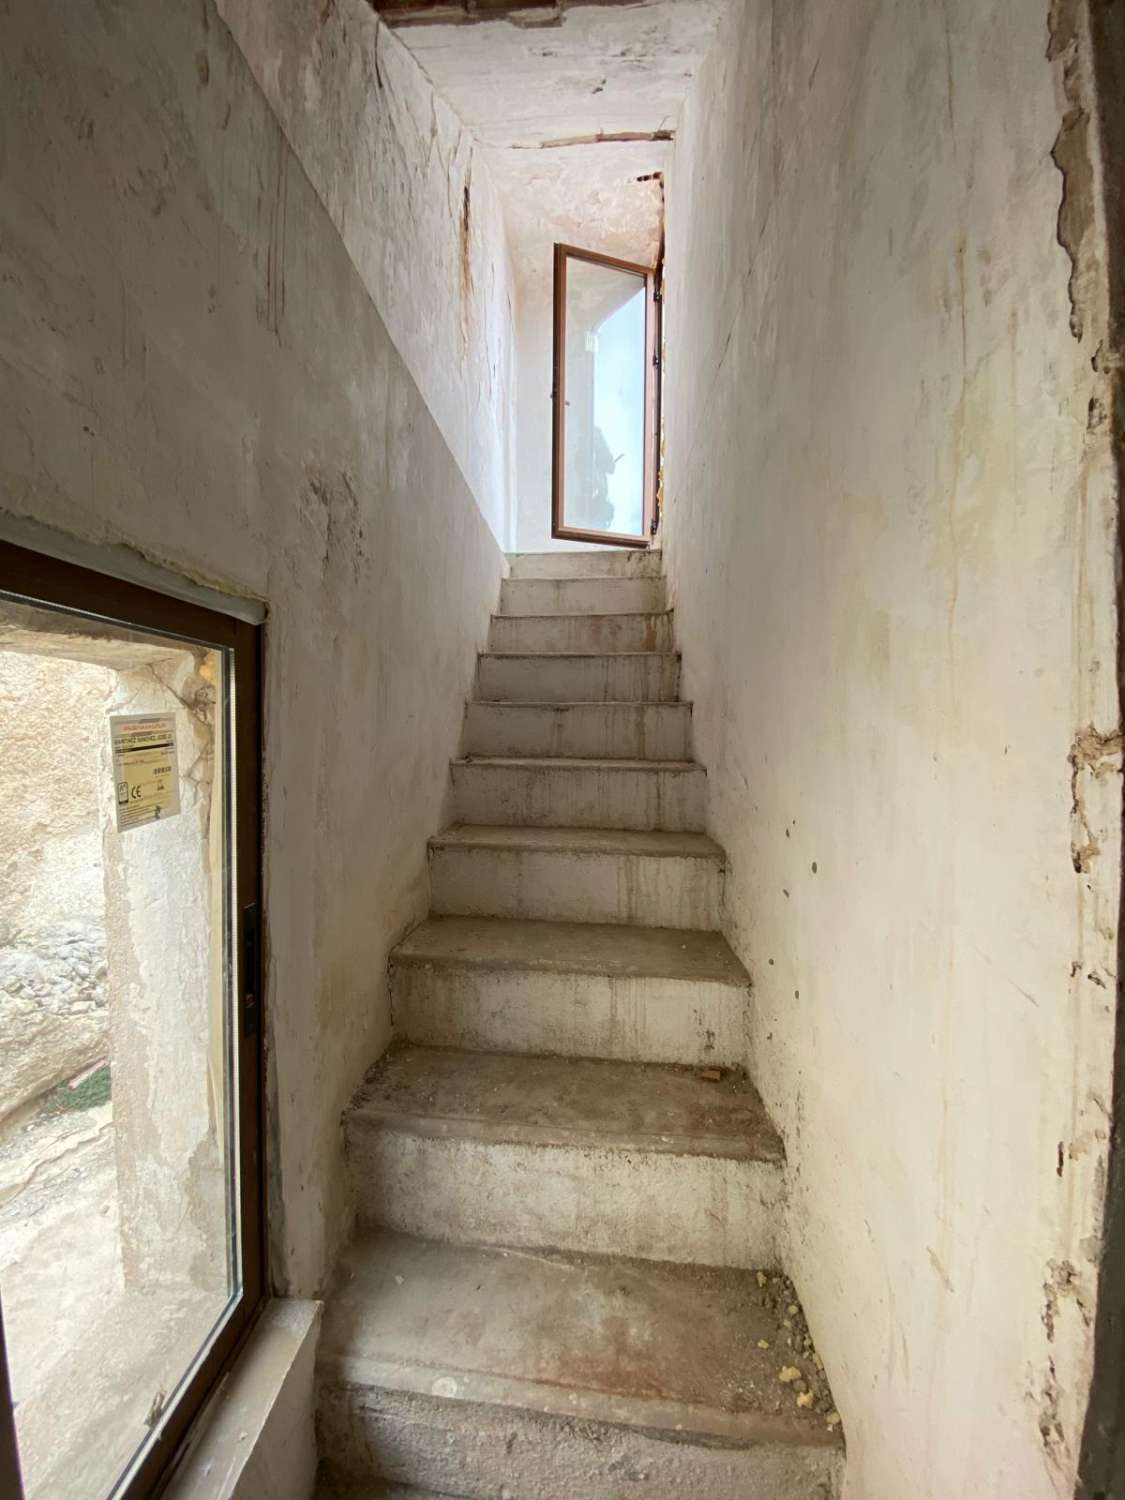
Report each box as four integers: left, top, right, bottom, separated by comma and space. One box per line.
564, 255, 648, 536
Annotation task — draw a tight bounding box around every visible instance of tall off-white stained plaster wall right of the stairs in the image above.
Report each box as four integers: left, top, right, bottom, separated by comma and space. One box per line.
665, 0, 1121, 1500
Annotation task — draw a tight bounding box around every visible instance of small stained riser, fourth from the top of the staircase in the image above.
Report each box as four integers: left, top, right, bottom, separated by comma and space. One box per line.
477, 651, 680, 704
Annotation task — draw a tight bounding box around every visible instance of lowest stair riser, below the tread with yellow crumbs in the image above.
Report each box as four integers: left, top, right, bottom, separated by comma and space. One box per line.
317, 1398, 845, 1500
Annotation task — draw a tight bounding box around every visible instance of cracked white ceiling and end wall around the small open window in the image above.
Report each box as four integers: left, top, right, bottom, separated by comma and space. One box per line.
372, 0, 732, 551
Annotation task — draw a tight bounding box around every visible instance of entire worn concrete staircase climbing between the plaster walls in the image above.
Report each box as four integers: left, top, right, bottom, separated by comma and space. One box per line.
318, 549, 843, 1500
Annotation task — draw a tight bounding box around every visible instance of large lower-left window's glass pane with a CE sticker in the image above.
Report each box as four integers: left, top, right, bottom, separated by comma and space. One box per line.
0, 597, 239, 1500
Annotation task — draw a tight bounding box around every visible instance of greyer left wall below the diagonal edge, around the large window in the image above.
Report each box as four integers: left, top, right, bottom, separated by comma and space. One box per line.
0, 0, 503, 1293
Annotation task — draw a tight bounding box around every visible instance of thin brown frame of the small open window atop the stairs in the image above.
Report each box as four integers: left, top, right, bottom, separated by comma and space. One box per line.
551, 245, 660, 548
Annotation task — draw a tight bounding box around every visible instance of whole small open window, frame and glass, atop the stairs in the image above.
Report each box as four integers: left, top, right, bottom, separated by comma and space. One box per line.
551, 245, 660, 548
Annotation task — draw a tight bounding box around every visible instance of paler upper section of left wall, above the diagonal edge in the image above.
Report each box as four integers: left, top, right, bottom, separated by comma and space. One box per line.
219, 0, 515, 548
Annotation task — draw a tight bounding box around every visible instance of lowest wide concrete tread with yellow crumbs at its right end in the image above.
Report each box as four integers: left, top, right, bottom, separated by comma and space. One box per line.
318, 1232, 842, 1446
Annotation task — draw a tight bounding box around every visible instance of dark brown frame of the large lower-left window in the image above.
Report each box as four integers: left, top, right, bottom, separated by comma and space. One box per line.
0, 542, 269, 1500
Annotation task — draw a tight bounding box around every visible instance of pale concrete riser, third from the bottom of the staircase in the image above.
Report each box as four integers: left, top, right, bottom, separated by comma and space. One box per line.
390, 963, 750, 1067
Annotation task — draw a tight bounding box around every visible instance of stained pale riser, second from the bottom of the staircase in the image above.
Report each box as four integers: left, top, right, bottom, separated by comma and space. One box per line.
347, 1116, 782, 1269
